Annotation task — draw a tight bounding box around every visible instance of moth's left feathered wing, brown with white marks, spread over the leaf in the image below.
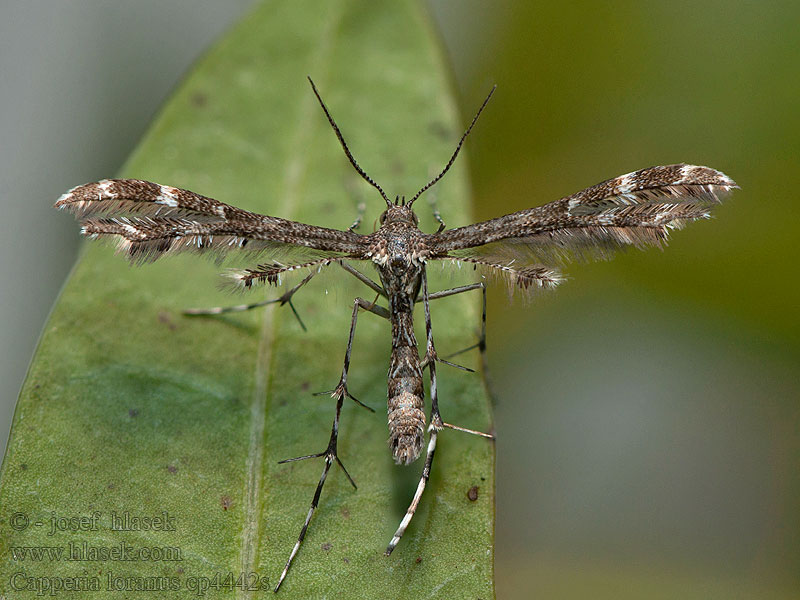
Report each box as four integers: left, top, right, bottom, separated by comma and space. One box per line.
55, 179, 365, 287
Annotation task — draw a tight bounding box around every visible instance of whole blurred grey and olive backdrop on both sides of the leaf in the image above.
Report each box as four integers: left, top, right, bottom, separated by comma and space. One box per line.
0, 0, 800, 598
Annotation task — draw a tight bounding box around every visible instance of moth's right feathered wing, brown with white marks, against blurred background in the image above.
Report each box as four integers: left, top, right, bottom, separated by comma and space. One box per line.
429, 164, 738, 291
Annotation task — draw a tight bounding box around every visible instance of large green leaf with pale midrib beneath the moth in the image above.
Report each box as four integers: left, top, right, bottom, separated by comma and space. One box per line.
0, 0, 494, 598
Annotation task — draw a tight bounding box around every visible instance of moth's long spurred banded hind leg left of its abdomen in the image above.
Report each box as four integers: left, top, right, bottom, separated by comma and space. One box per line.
275, 298, 389, 592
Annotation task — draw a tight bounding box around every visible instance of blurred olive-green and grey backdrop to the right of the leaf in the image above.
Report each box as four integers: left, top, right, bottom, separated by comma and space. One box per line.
432, 1, 800, 598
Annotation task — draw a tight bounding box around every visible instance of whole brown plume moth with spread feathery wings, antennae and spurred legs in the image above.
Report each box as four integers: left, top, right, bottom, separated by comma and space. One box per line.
56, 78, 738, 591
